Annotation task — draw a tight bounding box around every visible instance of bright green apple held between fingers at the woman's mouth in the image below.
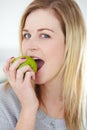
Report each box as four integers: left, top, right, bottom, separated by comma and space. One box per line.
12, 56, 37, 73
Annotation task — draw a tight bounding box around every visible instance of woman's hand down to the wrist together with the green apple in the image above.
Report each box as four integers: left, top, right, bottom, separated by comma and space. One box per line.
4, 56, 39, 111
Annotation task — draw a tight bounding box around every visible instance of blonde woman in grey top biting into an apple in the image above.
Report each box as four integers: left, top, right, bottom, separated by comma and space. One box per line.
0, 0, 87, 130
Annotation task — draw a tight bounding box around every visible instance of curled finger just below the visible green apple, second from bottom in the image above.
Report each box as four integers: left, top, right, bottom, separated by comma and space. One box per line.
16, 65, 32, 82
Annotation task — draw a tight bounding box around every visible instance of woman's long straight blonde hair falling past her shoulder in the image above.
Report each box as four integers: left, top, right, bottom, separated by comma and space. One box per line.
20, 0, 87, 130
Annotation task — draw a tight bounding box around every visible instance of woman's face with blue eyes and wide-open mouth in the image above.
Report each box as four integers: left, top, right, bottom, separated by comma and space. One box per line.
22, 9, 65, 84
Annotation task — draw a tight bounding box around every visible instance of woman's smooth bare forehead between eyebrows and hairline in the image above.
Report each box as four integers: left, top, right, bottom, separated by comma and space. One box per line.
25, 9, 60, 28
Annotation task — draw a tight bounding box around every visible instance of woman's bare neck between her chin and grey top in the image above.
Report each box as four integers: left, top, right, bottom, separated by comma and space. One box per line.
40, 77, 64, 118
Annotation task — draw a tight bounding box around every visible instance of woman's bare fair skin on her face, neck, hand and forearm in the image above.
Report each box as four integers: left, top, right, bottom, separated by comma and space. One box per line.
4, 9, 65, 130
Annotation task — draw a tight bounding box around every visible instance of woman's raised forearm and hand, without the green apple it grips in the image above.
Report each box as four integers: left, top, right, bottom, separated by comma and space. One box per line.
4, 59, 39, 130
